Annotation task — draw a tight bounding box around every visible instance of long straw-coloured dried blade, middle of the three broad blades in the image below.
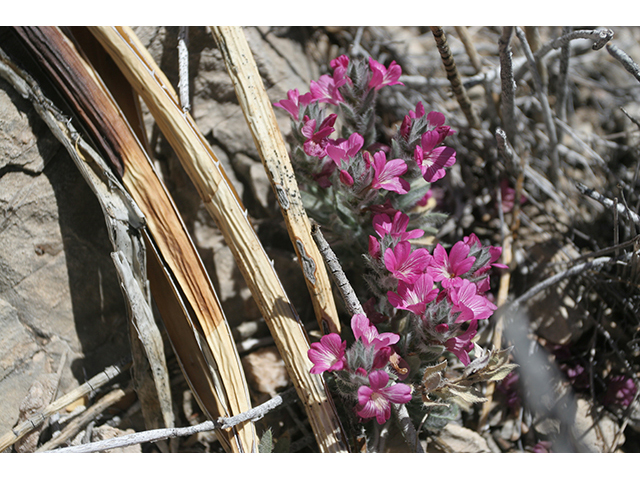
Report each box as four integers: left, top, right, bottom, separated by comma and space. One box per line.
90, 27, 348, 452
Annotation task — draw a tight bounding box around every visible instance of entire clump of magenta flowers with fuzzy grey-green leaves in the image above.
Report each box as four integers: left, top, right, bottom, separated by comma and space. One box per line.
275, 55, 502, 424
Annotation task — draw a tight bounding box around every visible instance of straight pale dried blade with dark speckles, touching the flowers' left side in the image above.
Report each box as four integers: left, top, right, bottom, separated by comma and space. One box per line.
210, 27, 340, 333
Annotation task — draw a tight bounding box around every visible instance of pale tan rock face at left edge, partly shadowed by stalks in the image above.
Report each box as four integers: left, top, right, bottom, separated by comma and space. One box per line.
0, 72, 129, 433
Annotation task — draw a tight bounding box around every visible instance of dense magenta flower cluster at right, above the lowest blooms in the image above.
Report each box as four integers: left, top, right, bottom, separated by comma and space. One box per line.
369, 227, 504, 365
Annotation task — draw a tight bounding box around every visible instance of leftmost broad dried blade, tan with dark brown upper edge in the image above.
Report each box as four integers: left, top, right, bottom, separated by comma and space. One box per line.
9, 27, 257, 451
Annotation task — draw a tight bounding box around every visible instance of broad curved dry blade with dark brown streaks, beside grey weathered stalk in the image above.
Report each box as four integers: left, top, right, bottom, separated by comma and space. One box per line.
7, 27, 257, 451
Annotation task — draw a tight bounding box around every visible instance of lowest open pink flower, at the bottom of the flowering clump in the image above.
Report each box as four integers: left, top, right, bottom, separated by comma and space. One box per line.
356, 370, 411, 425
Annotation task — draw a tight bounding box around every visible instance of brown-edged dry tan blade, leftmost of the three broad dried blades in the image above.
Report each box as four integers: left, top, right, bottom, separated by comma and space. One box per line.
17, 27, 257, 451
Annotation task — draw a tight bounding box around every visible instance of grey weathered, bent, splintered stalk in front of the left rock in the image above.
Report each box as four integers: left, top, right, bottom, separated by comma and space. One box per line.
0, 47, 174, 451
